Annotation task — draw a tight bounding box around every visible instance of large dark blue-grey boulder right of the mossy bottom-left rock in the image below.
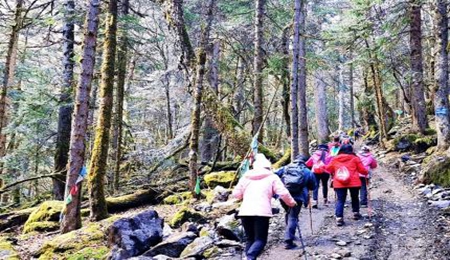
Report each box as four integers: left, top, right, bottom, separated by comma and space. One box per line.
107, 210, 164, 260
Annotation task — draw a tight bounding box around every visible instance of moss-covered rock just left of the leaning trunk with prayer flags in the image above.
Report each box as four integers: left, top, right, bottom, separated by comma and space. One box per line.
23, 200, 64, 234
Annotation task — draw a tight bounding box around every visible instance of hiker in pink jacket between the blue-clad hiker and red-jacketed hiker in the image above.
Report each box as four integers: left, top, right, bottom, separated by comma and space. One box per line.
306, 144, 332, 209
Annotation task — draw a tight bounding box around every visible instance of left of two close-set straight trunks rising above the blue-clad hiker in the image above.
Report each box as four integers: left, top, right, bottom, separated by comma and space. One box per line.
291, 0, 302, 161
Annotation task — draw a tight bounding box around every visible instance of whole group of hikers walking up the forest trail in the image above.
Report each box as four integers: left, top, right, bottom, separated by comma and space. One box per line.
232, 135, 377, 260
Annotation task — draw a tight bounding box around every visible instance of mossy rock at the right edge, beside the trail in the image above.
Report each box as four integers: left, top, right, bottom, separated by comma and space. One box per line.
422, 155, 450, 187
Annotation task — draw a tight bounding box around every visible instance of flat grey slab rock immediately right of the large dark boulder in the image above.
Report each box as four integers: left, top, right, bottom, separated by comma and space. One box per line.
143, 232, 197, 257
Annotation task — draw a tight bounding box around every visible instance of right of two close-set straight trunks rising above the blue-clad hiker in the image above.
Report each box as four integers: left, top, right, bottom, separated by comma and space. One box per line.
298, 0, 309, 156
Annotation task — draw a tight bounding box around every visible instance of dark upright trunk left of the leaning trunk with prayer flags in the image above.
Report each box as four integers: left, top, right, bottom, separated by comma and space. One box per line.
52, 0, 75, 200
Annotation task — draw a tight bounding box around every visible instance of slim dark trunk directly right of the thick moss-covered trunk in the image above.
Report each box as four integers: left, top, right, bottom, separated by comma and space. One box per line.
113, 0, 129, 192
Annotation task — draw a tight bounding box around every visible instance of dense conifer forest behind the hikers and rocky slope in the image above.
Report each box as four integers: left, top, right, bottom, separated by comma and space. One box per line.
0, 0, 450, 238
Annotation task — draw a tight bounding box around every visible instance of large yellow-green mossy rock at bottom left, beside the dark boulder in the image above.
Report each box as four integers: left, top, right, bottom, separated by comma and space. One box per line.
33, 216, 119, 260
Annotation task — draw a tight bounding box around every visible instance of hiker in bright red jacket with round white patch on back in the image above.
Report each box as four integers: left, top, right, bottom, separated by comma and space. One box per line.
324, 144, 368, 226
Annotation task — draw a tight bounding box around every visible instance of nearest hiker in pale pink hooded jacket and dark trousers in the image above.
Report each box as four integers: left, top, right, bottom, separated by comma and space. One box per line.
233, 154, 297, 260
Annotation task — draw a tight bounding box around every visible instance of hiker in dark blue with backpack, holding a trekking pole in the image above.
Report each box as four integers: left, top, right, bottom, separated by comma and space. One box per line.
275, 155, 315, 249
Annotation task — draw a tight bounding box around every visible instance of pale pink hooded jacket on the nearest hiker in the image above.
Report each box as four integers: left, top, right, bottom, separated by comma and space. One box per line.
233, 168, 295, 217
